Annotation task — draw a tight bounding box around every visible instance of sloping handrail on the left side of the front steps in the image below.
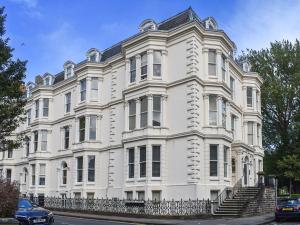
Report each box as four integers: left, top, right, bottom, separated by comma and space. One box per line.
211, 176, 243, 213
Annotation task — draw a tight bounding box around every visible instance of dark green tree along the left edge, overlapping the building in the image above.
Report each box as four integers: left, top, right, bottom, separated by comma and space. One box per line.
0, 7, 26, 155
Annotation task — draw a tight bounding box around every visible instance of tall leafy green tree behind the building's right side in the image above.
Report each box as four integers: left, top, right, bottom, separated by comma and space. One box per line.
238, 40, 300, 183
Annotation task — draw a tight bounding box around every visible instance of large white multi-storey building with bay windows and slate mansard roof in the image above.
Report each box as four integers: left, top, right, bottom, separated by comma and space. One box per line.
0, 8, 264, 199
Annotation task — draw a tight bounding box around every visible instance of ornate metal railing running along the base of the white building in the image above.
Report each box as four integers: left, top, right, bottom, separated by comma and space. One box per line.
32, 197, 211, 216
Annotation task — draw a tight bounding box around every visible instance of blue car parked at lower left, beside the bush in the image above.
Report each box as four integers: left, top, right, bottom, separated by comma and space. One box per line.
15, 199, 54, 225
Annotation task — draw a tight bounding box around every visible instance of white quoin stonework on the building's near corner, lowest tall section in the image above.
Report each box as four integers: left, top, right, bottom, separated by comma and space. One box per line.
187, 137, 200, 183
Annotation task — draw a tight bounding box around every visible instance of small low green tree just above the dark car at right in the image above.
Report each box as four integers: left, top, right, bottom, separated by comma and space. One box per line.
277, 155, 300, 194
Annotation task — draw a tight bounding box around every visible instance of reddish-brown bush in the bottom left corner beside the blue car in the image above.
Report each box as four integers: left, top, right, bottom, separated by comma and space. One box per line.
0, 178, 19, 217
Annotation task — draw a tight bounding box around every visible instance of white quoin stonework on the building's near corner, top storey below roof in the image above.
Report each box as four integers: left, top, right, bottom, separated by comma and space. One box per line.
186, 37, 200, 76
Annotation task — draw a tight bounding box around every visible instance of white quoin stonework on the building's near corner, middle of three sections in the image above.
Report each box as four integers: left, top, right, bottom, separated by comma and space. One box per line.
187, 81, 200, 130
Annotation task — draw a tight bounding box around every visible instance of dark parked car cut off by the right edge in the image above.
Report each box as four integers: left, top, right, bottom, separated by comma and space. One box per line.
275, 198, 300, 222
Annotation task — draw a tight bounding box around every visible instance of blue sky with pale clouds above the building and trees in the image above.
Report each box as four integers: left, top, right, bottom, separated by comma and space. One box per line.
0, 0, 300, 82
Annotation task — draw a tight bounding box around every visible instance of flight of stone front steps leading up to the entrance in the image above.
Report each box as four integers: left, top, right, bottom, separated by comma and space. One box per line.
215, 187, 261, 217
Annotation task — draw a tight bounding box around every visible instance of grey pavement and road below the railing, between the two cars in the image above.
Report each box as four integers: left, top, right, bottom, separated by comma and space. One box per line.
53, 211, 274, 225
